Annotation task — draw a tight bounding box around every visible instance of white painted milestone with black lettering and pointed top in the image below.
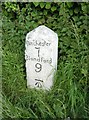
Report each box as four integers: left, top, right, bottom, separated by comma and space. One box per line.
25, 25, 58, 90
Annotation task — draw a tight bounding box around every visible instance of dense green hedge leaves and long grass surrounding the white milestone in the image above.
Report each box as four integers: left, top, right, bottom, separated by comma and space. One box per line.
2, 2, 89, 120
